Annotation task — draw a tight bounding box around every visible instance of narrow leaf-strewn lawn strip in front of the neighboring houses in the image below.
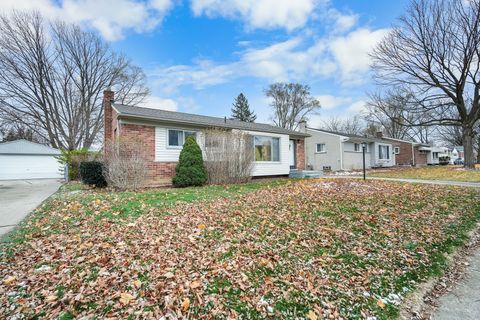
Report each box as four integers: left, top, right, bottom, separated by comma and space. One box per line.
369, 166, 480, 182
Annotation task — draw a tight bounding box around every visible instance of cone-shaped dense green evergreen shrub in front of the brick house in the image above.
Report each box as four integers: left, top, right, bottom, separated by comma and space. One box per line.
172, 136, 207, 187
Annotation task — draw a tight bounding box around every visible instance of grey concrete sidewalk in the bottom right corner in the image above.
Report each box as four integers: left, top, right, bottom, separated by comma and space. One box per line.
432, 250, 480, 320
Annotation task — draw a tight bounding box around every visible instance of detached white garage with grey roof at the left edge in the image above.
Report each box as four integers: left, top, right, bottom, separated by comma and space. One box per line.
0, 140, 63, 180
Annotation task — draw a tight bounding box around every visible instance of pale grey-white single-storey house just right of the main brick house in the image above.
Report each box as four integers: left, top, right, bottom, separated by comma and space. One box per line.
305, 127, 396, 171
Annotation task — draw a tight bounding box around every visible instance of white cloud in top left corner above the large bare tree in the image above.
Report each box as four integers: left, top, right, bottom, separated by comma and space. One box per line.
0, 0, 173, 41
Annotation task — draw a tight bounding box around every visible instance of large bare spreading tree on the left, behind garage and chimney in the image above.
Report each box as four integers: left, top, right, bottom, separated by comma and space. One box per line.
0, 12, 148, 150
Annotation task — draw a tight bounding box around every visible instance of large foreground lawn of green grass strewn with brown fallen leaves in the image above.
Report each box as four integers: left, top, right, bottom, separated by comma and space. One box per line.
0, 180, 480, 319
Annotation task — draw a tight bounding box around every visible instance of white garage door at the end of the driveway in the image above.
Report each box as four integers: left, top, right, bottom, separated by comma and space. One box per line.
0, 155, 62, 180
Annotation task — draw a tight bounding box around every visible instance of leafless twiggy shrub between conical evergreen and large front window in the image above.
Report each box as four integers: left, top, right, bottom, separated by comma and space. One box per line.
204, 129, 254, 184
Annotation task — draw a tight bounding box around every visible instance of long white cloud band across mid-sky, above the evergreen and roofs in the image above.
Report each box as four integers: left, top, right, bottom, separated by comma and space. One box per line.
150, 29, 387, 94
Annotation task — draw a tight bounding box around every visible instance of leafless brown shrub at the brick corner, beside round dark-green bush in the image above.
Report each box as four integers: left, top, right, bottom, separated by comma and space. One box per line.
104, 138, 148, 190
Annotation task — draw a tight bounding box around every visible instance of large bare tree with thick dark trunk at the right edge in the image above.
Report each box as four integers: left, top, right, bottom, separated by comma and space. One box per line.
372, 0, 480, 168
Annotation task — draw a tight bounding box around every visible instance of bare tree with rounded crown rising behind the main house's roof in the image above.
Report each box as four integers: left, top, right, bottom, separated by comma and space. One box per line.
265, 83, 320, 130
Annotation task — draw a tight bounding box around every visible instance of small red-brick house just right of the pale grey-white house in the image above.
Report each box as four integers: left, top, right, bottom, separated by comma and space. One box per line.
377, 132, 430, 166
